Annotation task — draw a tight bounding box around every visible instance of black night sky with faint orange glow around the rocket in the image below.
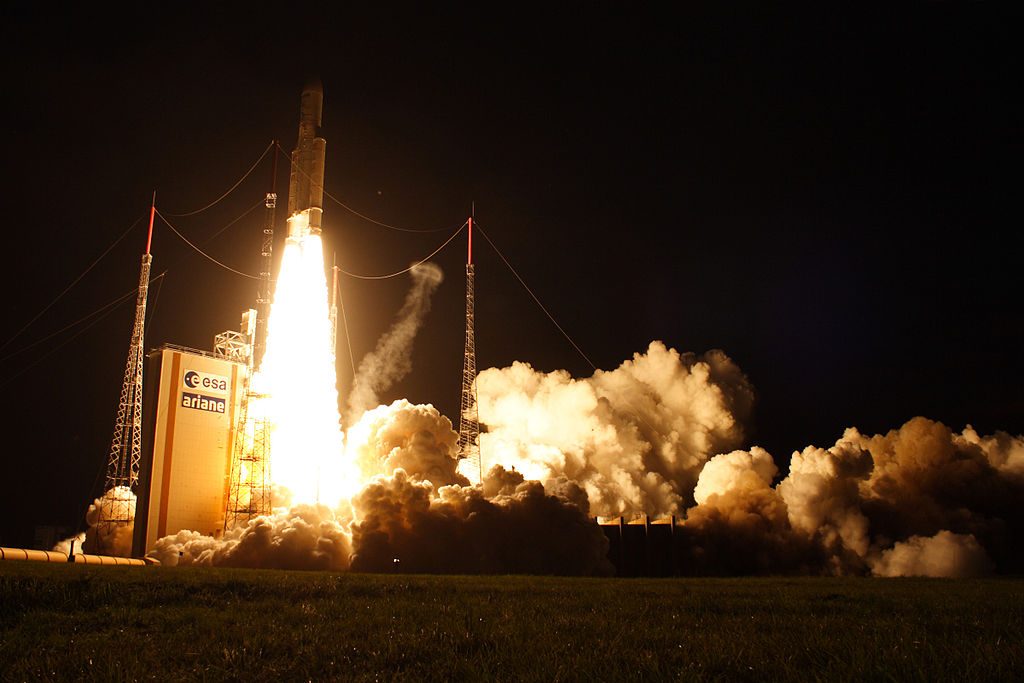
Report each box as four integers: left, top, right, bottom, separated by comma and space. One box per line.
0, 3, 1024, 545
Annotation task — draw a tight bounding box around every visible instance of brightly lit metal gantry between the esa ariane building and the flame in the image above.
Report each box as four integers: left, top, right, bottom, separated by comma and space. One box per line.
224, 310, 271, 531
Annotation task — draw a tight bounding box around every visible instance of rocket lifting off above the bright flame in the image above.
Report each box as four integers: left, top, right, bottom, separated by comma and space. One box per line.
288, 79, 327, 239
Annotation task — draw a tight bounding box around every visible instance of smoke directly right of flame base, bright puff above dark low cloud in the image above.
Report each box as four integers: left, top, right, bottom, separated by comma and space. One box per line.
349, 400, 610, 574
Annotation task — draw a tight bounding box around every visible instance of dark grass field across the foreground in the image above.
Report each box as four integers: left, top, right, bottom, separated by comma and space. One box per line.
0, 562, 1024, 681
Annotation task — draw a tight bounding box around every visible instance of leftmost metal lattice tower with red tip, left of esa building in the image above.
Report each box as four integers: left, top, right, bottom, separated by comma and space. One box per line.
96, 193, 157, 554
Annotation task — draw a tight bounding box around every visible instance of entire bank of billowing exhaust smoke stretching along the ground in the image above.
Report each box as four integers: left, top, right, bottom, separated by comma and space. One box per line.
134, 337, 1024, 577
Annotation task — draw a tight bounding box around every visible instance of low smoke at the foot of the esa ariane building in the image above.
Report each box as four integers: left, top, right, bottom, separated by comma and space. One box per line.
150, 505, 351, 569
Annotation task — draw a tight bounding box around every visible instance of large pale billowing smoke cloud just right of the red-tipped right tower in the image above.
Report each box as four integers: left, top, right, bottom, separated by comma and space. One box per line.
468, 342, 753, 516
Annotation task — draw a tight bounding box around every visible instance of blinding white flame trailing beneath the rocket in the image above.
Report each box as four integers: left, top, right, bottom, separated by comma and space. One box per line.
250, 227, 359, 506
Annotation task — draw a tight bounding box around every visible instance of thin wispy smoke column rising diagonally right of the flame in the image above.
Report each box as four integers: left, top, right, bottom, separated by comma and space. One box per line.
346, 263, 444, 424
